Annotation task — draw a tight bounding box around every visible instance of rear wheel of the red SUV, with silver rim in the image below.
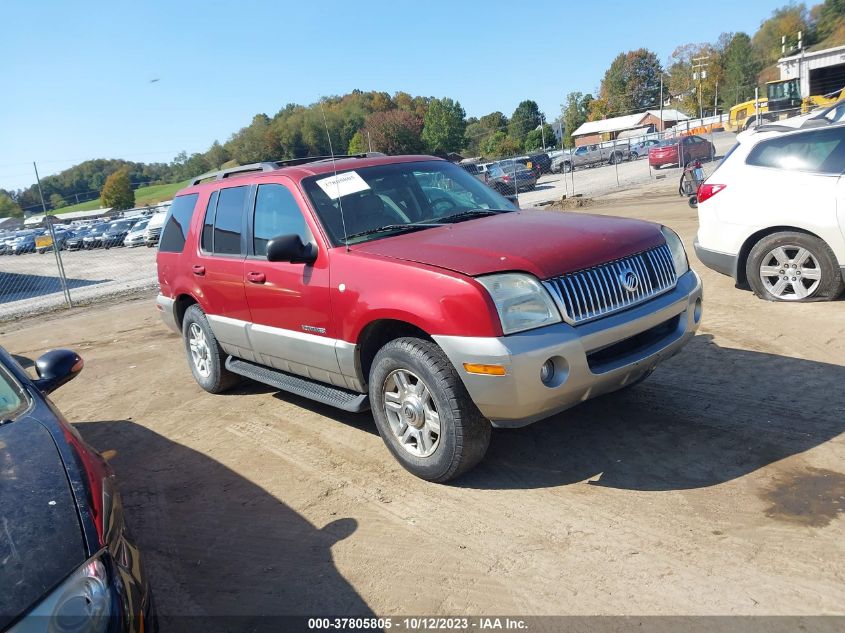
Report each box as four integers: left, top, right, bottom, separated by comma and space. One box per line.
182, 304, 241, 393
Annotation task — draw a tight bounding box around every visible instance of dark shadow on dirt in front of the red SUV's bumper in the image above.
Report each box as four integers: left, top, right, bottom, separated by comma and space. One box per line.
455, 335, 845, 491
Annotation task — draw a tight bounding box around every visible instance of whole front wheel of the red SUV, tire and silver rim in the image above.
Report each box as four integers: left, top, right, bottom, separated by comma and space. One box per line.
370, 338, 491, 482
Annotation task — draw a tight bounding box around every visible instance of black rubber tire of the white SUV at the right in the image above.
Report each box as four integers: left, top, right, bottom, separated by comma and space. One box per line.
745, 231, 845, 301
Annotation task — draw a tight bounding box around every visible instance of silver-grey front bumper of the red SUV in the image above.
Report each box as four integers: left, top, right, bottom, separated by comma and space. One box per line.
433, 270, 702, 427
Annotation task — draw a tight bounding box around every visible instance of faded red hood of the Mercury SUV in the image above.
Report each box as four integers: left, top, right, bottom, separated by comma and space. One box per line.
352, 209, 664, 279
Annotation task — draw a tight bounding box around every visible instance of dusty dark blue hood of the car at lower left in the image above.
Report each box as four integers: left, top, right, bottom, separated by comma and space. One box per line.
0, 418, 86, 630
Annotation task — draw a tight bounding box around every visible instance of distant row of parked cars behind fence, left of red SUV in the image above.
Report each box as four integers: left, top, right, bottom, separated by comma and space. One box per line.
0, 213, 165, 255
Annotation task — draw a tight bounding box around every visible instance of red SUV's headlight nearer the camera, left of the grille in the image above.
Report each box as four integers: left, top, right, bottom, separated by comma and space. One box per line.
478, 273, 561, 334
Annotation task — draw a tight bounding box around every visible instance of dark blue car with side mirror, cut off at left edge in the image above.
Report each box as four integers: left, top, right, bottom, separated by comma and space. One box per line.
0, 348, 157, 633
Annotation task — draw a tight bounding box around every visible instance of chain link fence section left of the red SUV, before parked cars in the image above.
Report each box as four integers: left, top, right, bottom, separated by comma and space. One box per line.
0, 208, 164, 321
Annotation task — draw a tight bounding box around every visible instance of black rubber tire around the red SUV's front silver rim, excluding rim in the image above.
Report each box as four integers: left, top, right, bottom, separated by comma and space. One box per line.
370, 338, 491, 483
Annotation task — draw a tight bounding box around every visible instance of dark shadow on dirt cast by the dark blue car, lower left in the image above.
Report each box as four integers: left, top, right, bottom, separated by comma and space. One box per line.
75, 420, 373, 631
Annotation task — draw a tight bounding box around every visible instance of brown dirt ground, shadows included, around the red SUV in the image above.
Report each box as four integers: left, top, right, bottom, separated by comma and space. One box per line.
0, 186, 845, 615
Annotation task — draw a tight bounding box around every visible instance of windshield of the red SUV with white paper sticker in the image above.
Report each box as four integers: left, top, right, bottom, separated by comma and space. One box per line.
302, 160, 516, 246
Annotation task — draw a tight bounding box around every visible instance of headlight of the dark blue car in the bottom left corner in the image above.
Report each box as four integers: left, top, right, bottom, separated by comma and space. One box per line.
8, 557, 112, 633
